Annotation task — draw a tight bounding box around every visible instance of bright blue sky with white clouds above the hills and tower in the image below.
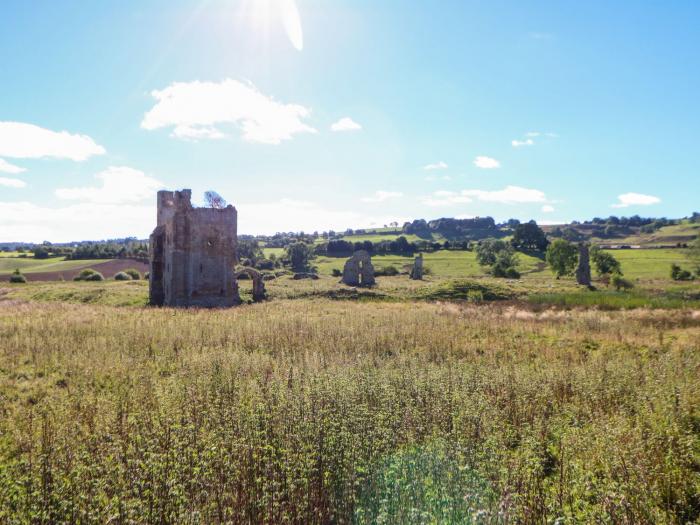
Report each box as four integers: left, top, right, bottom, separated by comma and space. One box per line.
0, 0, 700, 241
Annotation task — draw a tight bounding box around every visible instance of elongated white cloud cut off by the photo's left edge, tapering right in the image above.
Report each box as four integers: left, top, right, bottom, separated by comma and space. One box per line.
0, 122, 105, 161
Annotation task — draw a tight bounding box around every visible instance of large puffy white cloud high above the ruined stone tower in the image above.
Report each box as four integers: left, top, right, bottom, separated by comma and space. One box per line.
141, 79, 316, 144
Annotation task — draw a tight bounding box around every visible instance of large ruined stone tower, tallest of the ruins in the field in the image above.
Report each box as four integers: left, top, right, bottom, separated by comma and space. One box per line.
149, 190, 240, 307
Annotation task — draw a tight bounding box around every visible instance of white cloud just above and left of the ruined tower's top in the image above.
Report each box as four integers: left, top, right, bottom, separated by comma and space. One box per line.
56, 166, 162, 204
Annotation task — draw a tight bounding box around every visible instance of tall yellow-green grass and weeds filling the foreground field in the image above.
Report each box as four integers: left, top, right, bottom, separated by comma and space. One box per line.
0, 299, 700, 523
